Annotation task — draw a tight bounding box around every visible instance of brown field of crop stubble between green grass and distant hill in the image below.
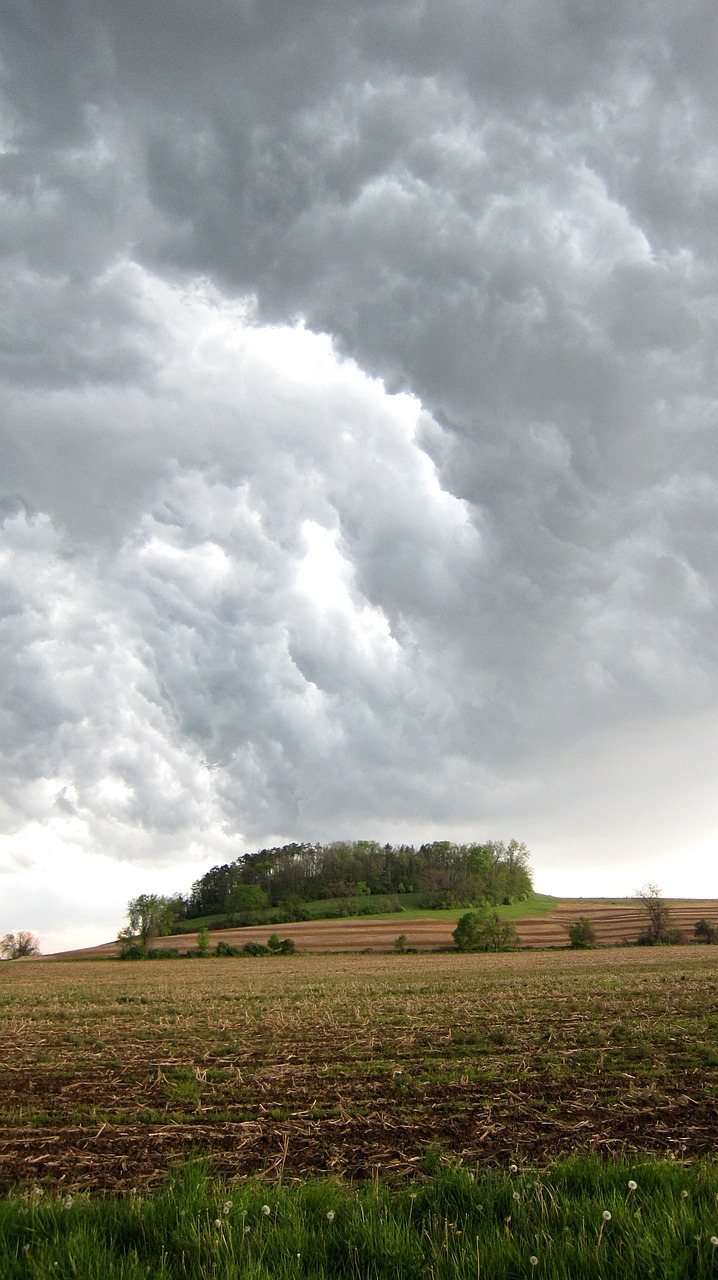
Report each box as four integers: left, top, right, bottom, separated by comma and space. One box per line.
0, 947, 718, 1189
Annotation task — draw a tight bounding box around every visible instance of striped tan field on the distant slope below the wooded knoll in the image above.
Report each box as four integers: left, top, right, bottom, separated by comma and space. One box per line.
53, 895, 718, 959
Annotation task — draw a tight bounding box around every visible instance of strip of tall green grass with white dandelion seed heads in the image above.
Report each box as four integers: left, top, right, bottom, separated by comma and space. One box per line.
0, 1157, 718, 1280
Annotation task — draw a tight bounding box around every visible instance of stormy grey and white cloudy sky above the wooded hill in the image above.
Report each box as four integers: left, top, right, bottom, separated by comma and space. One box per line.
0, 0, 718, 951
